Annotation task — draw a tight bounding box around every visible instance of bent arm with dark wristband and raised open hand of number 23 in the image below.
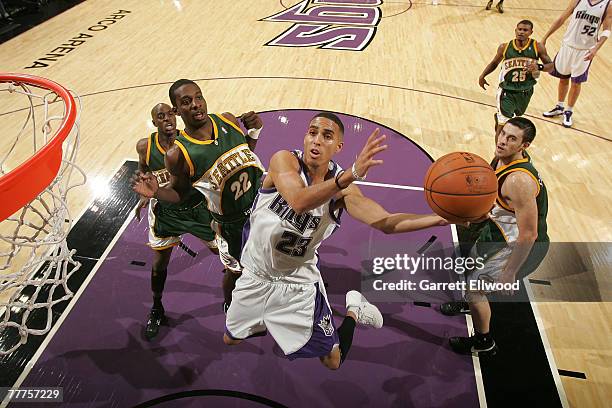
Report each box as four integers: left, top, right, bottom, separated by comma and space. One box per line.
268, 129, 387, 214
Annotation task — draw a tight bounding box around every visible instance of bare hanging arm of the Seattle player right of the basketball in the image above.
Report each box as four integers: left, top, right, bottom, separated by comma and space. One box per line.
501, 172, 538, 292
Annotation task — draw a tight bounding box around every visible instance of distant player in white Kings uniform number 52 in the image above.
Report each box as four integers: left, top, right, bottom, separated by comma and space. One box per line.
533, 0, 612, 127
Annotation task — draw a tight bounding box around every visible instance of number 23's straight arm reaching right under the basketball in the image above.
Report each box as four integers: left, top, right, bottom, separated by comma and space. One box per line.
338, 185, 448, 234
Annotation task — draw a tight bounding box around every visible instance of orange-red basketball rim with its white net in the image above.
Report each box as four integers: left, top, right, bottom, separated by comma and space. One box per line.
0, 73, 85, 355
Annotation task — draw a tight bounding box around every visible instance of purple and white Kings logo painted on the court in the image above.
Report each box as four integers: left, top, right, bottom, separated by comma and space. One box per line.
261, 0, 382, 51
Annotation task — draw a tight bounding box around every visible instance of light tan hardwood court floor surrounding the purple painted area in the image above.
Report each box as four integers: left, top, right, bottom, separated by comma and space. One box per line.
0, 0, 612, 407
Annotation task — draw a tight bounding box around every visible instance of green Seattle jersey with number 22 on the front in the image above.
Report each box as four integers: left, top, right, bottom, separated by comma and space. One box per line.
175, 114, 264, 220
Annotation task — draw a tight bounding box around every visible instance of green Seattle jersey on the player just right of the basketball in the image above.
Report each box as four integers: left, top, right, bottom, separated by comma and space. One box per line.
477, 154, 549, 255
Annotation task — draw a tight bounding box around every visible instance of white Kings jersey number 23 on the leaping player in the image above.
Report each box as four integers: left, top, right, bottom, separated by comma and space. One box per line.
240, 150, 342, 284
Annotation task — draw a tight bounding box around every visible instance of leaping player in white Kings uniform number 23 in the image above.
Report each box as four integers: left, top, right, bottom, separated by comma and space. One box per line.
223, 112, 448, 370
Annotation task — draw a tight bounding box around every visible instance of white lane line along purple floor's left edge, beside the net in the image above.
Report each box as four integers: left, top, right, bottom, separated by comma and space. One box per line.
0, 159, 134, 408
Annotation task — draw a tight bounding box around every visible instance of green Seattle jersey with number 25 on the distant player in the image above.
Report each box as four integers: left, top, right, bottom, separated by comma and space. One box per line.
499, 38, 538, 91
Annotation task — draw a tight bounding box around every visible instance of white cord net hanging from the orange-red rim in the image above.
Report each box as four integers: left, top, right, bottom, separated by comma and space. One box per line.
0, 76, 86, 355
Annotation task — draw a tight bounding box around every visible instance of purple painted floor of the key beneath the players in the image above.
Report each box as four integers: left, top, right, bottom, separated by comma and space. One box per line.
17, 110, 478, 407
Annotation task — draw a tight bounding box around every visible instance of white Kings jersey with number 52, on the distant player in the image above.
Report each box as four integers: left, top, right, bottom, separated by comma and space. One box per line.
563, 0, 610, 50
